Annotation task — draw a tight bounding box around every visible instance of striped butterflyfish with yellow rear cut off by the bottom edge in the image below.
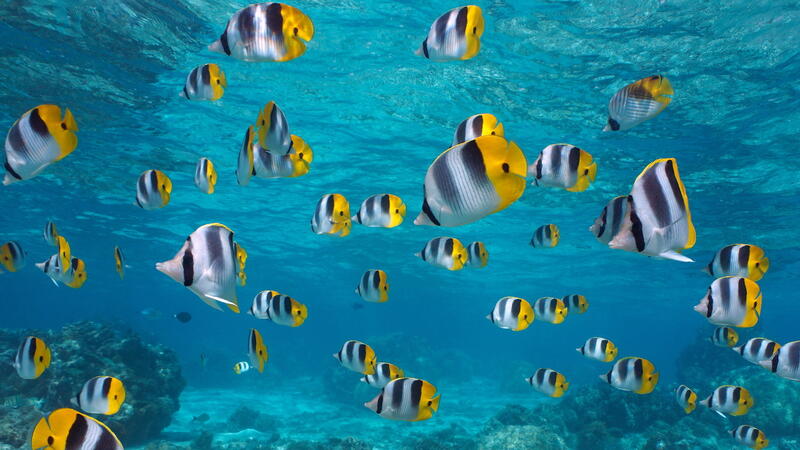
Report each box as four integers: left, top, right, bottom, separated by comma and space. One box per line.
31, 408, 123, 450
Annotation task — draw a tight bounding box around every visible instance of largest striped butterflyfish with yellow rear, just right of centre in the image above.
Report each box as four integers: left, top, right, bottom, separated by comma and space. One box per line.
414, 136, 527, 227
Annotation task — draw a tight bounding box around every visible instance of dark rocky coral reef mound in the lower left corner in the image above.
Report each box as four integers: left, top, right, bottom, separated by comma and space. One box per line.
0, 321, 185, 448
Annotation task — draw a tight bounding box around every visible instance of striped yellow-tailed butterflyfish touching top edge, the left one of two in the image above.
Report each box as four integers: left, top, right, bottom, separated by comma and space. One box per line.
208, 2, 314, 62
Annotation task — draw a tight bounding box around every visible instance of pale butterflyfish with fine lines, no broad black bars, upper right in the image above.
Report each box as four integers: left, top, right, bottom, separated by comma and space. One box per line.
603, 75, 675, 131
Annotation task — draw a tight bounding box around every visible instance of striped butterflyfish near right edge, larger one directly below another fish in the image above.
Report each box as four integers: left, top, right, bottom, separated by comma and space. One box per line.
694, 277, 762, 328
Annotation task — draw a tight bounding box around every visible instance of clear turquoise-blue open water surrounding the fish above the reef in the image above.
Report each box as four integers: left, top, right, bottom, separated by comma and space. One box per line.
0, 0, 800, 448
